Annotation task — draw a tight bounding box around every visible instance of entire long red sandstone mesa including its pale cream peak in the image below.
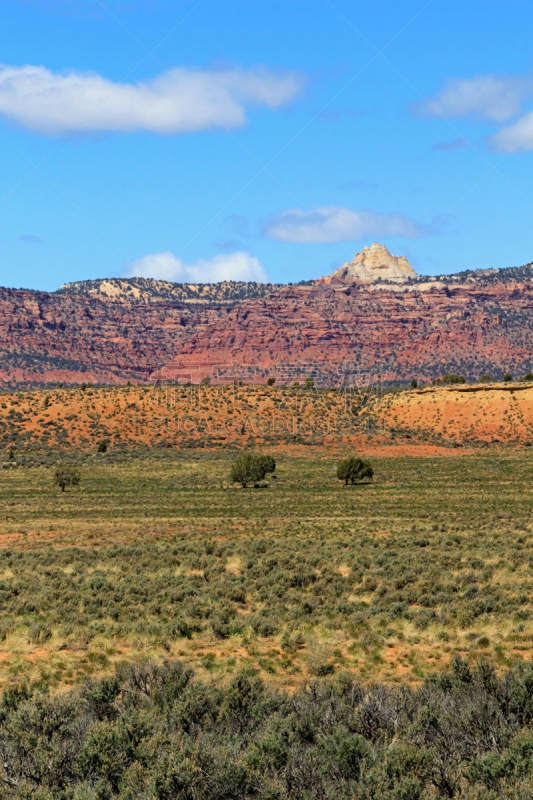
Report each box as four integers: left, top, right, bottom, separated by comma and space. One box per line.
0, 245, 533, 389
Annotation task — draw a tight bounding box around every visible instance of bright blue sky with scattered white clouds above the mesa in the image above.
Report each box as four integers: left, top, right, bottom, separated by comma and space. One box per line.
0, 0, 533, 290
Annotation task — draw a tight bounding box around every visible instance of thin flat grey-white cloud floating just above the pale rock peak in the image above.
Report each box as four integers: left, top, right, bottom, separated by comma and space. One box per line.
263, 206, 424, 244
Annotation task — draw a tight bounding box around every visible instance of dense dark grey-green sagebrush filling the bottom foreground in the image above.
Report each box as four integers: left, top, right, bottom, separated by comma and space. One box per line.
5, 659, 533, 800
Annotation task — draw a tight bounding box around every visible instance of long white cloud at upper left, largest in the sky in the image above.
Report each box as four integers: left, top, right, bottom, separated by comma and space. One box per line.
0, 65, 303, 135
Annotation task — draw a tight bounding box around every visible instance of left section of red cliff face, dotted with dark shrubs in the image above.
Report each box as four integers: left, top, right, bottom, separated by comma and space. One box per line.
0, 289, 221, 386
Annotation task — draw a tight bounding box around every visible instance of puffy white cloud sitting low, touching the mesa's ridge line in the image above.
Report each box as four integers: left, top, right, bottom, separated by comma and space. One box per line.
124, 250, 268, 283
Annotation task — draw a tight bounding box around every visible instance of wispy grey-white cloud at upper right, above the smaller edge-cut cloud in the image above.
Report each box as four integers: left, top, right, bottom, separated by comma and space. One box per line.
412, 75, 533, 122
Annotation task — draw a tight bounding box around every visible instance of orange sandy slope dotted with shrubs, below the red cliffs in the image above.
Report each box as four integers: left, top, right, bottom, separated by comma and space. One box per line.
0, 383, 533, 449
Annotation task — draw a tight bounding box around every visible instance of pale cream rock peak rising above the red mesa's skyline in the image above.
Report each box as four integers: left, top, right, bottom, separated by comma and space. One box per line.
323, 242, 418, 285
